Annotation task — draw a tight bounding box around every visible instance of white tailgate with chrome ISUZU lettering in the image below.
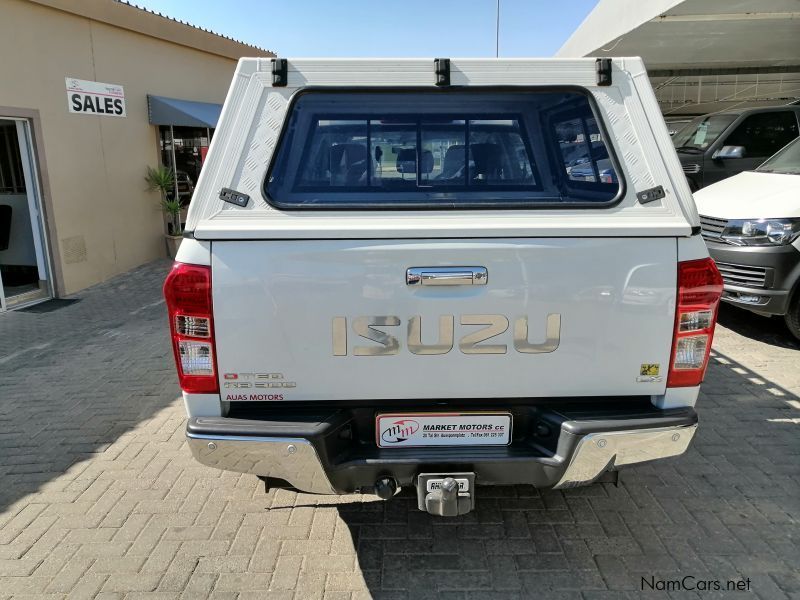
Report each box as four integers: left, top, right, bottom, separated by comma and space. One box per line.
212, 238, 677, 401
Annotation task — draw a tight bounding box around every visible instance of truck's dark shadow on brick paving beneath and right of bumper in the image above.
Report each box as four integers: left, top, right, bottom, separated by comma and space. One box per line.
328, 352, 800, 599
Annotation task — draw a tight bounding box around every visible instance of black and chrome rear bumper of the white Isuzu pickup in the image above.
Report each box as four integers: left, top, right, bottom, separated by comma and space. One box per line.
187, 406, 697, 494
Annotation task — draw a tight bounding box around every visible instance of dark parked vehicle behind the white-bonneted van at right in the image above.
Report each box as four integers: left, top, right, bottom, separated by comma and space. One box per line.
672, 106, 800, 192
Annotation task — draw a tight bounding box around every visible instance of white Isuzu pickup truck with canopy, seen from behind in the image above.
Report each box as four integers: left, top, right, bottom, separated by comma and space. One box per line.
164, 58, 722, 516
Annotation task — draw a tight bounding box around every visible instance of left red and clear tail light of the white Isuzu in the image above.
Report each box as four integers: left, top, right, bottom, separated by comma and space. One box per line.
164, 262, 219, 394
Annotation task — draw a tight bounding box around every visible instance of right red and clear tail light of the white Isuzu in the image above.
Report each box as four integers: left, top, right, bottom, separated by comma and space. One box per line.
667, 258, 722, 387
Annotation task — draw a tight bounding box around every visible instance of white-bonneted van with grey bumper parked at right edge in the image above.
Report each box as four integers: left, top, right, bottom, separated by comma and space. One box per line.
695, 138, 800, 339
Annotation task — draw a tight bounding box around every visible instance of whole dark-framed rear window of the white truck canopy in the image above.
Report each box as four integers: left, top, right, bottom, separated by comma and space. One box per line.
265, 90, 620, 209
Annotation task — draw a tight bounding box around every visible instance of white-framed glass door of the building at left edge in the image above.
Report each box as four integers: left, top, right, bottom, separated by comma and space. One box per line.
0, 117, 52, 310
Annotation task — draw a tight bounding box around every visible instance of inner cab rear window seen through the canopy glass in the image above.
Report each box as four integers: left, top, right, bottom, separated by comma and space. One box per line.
298, 117, 536, 190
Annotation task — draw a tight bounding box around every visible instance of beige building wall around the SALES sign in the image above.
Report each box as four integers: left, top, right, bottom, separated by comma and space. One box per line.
0, 0, 244, 294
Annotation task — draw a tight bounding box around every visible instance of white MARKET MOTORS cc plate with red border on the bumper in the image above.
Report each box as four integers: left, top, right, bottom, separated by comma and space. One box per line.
375, 412, 511, 448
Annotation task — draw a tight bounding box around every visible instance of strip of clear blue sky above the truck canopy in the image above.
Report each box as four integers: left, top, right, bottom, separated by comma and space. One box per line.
132, 0, 597, 57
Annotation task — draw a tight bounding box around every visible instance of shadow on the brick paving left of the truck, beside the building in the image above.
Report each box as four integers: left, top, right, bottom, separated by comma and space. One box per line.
0, 261, 180, 511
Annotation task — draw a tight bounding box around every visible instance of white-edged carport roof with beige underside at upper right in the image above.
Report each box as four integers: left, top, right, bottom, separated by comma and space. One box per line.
557, 0, 800, 118
